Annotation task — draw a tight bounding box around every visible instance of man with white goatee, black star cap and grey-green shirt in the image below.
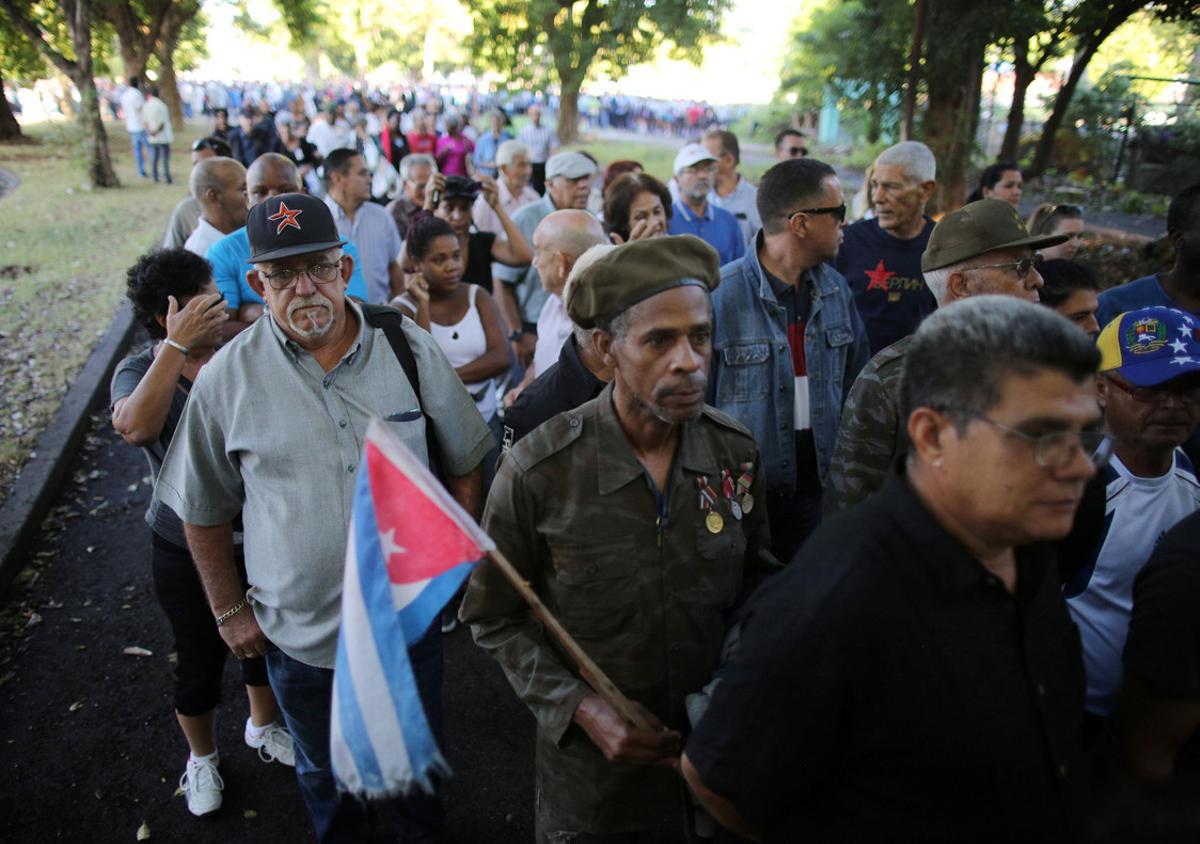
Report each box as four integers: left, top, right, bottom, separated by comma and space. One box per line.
155, 193, 493, 842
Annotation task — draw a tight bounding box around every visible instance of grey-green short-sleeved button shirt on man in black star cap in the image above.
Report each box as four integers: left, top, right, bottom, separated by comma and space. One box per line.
155, 300, 494, 668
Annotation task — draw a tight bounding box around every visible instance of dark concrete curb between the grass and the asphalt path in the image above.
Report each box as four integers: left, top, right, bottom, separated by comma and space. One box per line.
0, 300, 137, 599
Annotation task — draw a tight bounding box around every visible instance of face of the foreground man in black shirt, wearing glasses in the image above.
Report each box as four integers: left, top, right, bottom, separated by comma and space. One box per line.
931, 370, 1099, 547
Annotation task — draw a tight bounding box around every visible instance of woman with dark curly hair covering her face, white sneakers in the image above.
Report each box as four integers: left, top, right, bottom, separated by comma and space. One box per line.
112, 249, 295, 815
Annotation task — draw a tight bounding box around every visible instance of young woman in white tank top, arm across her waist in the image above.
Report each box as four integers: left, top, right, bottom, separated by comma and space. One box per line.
391, 216, 509, 429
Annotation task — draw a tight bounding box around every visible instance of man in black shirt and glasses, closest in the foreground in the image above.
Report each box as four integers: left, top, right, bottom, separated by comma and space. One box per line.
682, 297, 1099, 843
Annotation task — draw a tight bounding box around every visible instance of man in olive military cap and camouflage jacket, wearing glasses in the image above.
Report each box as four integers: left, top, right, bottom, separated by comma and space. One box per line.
824, 199, 1066, 513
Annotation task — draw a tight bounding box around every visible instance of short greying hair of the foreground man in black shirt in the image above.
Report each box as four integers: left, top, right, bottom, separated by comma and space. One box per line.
900, 295, 1100, 423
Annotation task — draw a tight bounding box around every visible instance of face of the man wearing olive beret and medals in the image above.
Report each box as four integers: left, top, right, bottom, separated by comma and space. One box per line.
599, 285, 713, 424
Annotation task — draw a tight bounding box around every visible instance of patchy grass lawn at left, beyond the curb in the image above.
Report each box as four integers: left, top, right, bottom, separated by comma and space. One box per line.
0, 116, 191, 499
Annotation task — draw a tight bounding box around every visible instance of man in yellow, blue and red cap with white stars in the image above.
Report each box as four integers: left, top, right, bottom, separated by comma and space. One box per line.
1063, 307, 1200, 735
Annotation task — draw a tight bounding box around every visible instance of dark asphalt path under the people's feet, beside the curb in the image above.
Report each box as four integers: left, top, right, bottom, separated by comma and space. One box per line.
0, 386, 534, 844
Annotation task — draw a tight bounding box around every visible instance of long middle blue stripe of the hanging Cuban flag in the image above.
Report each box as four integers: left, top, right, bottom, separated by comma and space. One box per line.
354, 461, 445, 791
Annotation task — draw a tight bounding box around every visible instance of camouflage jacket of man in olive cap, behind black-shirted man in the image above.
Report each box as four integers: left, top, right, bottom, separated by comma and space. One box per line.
824, 335, 912, 515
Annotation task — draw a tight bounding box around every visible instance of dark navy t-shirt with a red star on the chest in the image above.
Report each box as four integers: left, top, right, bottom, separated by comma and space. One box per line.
834, 217, 937, 354
